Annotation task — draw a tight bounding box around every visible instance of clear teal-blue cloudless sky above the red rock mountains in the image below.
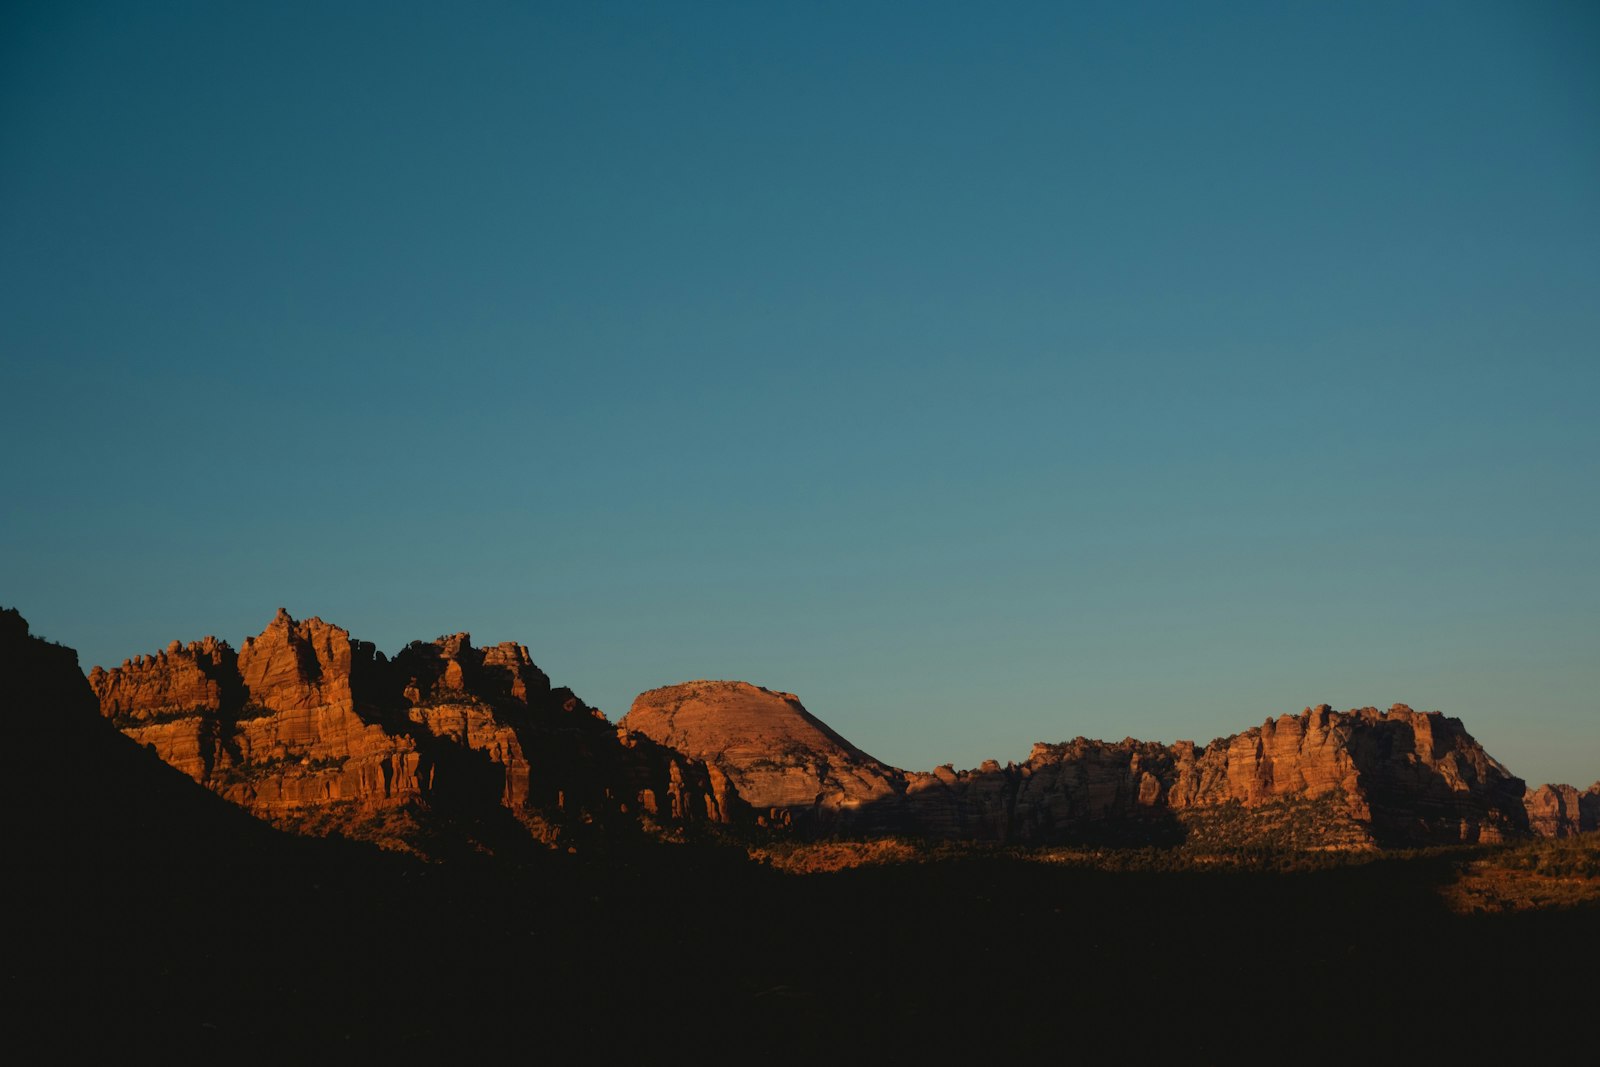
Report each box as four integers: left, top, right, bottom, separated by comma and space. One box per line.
0, 0, 1600, 784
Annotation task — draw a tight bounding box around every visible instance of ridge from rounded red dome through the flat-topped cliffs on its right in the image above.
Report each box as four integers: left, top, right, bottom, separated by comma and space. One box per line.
622, 681, 1581, 848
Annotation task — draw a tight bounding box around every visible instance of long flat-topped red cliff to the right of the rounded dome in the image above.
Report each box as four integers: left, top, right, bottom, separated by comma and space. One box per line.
907, 705, 1526, 848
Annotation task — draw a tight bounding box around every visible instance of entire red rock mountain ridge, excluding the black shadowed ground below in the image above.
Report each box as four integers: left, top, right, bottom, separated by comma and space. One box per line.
59, 609, 1600, 854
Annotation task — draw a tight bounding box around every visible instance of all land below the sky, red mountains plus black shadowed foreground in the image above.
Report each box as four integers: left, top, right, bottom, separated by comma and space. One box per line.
0, 611, 1600, 1064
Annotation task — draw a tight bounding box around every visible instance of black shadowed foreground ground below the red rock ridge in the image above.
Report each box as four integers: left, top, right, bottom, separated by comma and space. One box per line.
5, 614, 1600, 1064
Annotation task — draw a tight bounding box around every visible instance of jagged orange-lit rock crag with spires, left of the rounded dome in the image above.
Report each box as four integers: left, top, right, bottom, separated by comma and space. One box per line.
88, 609, 736, 843
